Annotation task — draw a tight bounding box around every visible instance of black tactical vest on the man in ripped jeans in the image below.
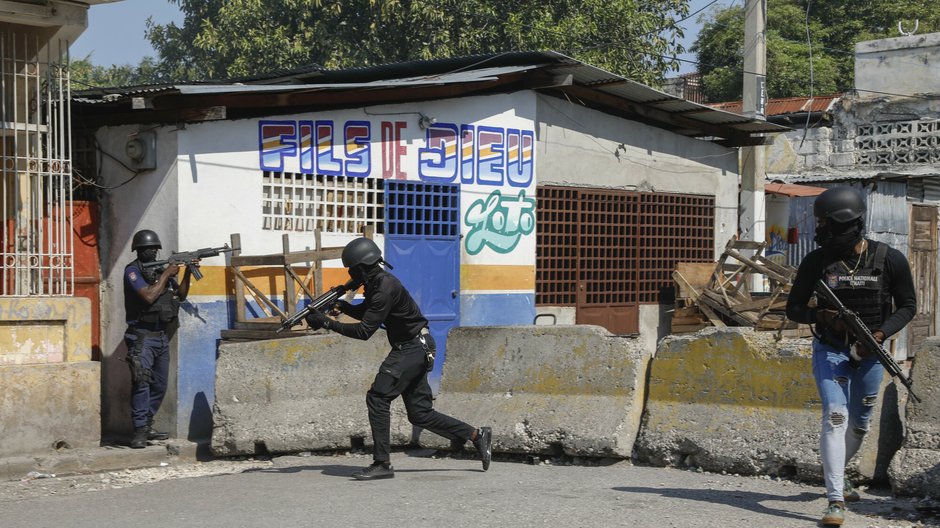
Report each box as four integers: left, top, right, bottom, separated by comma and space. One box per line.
821, 240, 891, 342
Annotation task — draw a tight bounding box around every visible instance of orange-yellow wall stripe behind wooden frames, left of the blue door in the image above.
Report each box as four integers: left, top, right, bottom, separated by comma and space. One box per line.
187, 266, 349, 298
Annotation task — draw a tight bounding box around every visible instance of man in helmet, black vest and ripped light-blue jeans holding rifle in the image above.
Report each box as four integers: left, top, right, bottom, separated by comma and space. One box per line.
787, 187, 917, 525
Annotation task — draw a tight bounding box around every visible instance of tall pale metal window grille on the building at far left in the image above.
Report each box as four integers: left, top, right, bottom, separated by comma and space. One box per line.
0, 30, 75, 296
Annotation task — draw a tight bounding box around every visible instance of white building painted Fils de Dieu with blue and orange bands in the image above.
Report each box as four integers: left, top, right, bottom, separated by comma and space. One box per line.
74, 52, 783, 438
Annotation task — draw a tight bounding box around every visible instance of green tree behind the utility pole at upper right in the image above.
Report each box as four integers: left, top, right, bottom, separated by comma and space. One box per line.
692, 0, 940, 102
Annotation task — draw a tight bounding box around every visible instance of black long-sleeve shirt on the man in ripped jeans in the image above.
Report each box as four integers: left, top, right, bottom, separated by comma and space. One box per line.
787, 241, 917, 337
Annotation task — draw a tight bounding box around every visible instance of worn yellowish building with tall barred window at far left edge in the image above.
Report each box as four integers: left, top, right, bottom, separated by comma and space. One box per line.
0, 0, 121, 456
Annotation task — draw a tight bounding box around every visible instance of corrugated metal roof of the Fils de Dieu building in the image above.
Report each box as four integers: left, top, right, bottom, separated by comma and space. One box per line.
73, 51, 789, 139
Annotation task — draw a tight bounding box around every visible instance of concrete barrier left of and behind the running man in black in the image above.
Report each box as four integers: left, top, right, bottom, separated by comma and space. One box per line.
211, 331, 412, 455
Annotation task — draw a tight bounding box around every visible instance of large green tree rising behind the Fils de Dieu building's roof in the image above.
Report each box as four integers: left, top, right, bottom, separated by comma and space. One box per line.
147, 0, 688, 83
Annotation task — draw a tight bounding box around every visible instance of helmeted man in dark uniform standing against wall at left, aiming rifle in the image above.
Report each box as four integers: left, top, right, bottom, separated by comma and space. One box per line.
124, 229, 190, 449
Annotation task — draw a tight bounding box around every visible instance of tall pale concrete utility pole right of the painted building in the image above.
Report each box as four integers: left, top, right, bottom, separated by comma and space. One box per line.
738, 0, 767, 291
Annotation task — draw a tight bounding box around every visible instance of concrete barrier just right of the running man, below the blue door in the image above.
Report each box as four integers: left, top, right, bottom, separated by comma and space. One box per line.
421, 325, 650, 458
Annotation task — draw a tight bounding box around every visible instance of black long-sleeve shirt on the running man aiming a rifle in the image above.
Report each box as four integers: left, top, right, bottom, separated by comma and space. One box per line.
330, 267, 428, 344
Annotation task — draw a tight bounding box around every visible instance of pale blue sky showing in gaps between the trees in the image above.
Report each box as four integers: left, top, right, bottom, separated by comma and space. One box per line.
70, 0, 720, 73
